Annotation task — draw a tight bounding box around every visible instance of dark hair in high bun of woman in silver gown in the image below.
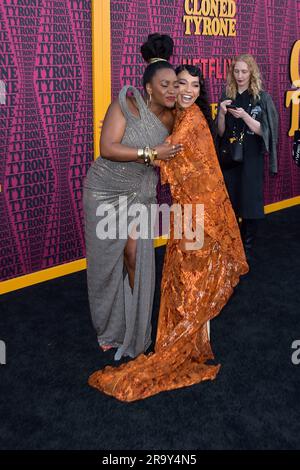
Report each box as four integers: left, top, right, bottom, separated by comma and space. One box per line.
141, 33, 174, 90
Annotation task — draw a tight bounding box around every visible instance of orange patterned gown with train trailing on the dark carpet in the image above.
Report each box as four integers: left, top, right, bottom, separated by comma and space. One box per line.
89, 104, 248, 402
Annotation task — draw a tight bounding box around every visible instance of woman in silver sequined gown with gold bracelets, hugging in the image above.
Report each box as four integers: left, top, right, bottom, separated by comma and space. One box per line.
83, 34, 181, 360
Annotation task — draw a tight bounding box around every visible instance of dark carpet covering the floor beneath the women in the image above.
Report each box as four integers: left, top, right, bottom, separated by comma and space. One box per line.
0, 206, 300, 450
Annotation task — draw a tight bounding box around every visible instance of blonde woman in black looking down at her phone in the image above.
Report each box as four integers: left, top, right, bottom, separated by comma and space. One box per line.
217, 54, 278, 260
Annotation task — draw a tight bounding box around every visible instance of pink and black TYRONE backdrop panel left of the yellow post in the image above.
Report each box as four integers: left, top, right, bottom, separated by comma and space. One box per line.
0, 0, 93, 280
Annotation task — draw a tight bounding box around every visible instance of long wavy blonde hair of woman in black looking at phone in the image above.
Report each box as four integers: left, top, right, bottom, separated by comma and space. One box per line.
226, 54, 262, 100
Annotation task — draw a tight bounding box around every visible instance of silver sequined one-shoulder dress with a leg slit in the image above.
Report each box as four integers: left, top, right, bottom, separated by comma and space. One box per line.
83, 86, 168, 359
